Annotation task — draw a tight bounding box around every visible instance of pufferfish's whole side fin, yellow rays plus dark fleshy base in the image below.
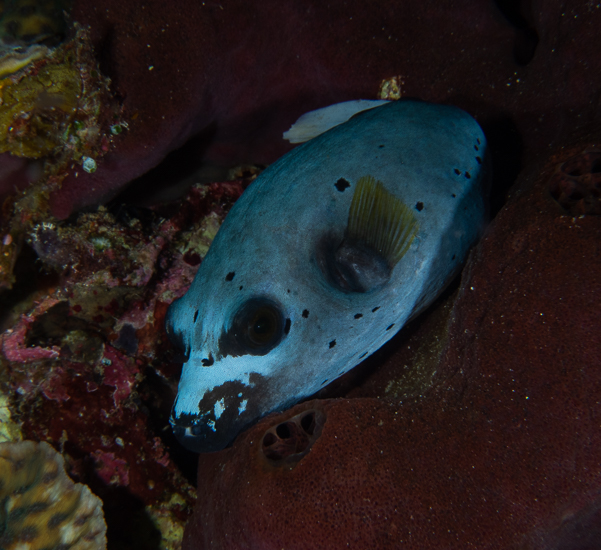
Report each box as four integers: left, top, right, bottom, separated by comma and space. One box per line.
318, 176, 418, 292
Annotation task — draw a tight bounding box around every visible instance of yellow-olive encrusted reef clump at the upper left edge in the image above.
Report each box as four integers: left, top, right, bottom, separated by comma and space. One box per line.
0, 25, 120, 288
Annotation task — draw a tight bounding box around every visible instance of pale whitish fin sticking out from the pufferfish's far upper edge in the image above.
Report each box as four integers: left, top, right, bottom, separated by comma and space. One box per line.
283, 99, 390, 143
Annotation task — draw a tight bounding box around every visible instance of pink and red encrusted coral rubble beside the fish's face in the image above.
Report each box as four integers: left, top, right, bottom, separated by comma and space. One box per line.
0, 180, 248, 548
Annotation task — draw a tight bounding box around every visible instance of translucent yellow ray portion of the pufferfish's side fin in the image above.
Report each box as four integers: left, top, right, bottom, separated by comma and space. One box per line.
346, 176, 419, 267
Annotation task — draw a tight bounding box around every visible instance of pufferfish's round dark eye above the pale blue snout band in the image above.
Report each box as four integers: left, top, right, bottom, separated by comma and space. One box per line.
232, 298, 284, 355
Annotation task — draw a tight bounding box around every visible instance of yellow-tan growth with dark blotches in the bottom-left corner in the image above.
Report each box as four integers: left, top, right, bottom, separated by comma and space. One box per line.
0, 441, 106, 550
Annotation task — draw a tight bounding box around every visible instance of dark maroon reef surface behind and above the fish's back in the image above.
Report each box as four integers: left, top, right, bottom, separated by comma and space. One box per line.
42, 0, 601, 217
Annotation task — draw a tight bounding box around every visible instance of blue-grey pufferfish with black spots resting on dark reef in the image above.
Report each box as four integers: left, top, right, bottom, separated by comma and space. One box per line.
167, 100, 489, 452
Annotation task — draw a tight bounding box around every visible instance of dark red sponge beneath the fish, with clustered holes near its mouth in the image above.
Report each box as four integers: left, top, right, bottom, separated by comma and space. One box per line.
184, 140, 601, 550
